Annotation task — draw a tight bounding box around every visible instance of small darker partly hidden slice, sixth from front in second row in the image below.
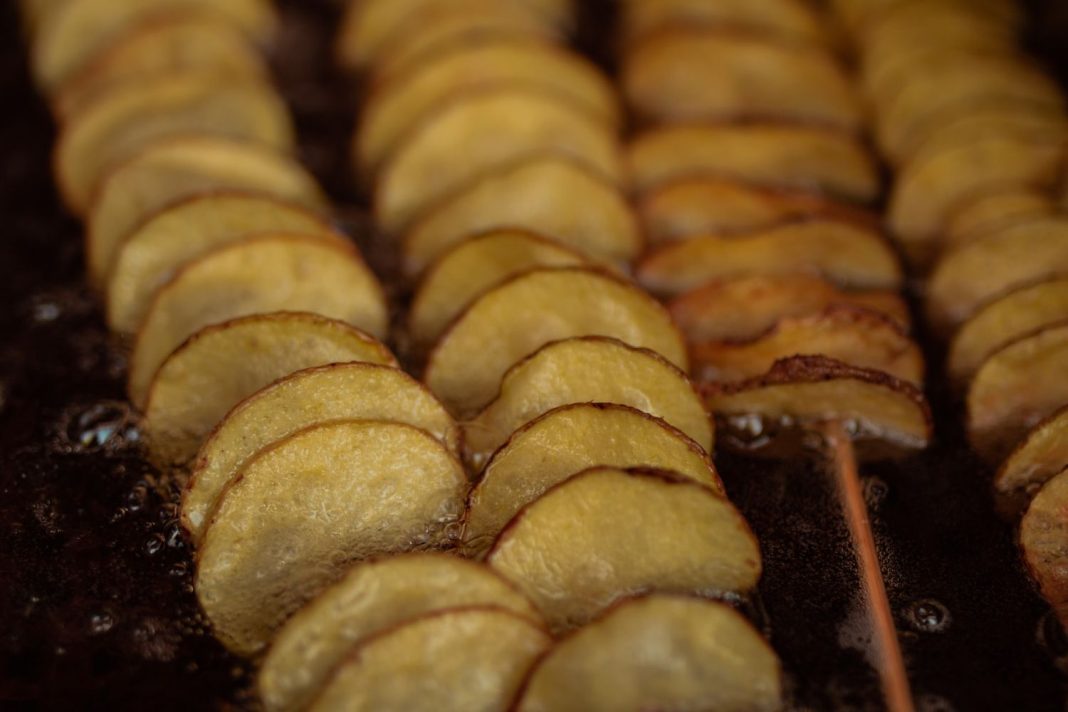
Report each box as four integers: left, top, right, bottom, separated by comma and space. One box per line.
408, 230, 586, 347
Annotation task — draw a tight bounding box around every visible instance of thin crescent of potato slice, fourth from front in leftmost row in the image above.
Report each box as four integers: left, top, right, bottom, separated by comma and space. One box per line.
182, 362, 460, 542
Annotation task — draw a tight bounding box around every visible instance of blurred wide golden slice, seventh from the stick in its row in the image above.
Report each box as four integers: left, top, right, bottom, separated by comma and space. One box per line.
623, 28, 862, 130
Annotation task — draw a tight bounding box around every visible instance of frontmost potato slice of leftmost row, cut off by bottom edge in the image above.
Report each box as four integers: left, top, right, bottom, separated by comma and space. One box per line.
309, 606, 552, 712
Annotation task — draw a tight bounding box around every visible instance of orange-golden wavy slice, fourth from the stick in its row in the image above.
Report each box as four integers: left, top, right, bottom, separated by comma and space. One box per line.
638, 220, 901, 296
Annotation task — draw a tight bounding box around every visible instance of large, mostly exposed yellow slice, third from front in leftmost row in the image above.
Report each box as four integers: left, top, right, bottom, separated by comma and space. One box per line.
194, 421, 467, 655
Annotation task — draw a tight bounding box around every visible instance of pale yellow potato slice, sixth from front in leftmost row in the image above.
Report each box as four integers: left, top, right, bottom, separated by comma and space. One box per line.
128, 234, 389, 408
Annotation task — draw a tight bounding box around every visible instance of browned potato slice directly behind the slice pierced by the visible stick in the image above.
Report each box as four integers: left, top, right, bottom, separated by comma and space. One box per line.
690, 305, 924, 384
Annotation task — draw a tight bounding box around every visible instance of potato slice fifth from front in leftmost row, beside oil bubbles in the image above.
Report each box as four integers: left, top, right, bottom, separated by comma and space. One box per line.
142, 312, 396, 466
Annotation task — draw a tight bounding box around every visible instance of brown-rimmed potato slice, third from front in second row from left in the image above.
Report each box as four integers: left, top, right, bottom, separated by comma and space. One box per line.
462, 402, 723, 557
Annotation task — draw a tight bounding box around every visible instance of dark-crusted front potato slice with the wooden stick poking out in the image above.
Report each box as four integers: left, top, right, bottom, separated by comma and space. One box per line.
703, 355, 931, 458
